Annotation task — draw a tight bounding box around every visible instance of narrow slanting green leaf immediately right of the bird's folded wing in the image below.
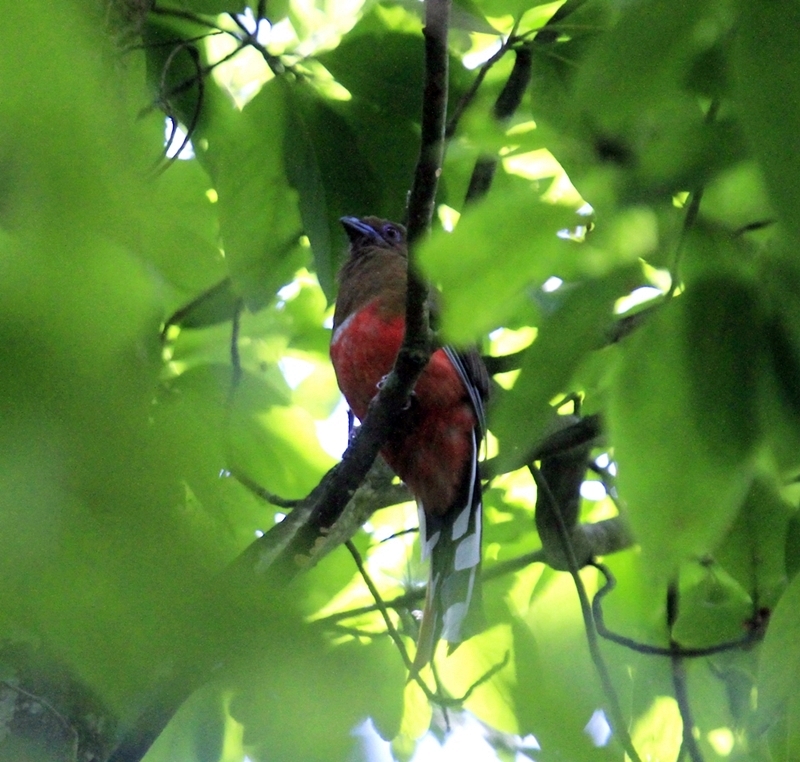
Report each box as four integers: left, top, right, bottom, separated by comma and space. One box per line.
491, 269, 638, 471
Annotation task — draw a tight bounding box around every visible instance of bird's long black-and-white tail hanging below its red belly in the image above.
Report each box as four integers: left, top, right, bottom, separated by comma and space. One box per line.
414, 435, 484, 669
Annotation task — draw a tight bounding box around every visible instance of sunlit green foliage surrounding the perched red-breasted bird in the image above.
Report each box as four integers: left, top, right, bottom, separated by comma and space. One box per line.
0, 0, 800, 762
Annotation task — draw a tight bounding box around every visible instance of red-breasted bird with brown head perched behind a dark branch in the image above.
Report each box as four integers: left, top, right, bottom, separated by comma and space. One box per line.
331, 217, 489, 667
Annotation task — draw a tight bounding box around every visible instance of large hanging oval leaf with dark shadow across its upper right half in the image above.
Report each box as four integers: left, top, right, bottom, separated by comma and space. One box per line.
609, 277, 760, 576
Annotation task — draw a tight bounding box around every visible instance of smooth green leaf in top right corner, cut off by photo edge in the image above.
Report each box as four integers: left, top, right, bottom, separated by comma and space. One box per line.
732, 0, 800, 240
